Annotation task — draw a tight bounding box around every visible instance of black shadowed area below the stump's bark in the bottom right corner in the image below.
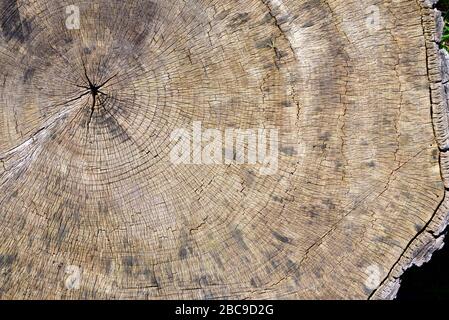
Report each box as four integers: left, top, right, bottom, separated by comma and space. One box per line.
397, 235, 449, 300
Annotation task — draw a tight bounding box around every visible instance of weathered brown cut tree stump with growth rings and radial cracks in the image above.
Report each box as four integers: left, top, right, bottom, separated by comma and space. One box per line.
0, 0, 449, 299
